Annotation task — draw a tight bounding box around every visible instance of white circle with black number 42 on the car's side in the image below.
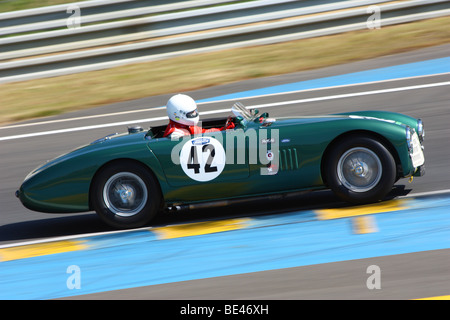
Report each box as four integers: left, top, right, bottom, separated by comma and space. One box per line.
180, 137, 226, 182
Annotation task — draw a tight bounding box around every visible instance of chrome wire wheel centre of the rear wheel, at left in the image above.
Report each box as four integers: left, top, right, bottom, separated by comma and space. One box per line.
103, 172, 148, 217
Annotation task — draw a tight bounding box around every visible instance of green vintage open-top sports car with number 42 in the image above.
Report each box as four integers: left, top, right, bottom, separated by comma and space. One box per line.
16, 103, 425, 228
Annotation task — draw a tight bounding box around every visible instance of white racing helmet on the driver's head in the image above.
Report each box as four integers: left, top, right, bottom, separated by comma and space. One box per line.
166, 94, 200, 126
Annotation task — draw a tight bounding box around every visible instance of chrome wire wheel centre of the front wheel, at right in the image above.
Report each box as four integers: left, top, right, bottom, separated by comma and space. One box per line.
337, 148, 383, 192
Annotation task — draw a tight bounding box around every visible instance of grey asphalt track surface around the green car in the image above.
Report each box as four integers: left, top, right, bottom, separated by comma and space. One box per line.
0, 45, 450, 299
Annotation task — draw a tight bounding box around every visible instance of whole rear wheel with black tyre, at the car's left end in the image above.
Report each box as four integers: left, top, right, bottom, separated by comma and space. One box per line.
91, 161, 162, 229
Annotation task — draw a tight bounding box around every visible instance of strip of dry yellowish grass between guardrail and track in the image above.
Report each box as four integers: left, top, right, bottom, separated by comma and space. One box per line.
0, 17, 450, 123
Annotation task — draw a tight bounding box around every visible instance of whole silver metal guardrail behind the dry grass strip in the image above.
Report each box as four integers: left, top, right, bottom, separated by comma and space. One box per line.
0, 0, 450, 83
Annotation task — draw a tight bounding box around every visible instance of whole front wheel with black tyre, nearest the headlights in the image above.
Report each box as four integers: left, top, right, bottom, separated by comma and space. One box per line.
325, 136, 397, 204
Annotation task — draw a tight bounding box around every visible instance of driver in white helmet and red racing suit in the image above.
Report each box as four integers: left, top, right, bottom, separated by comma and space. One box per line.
163, 94, 234, 138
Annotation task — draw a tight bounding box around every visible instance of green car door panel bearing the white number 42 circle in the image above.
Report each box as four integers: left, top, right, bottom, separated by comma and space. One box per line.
148, 130, 249, 199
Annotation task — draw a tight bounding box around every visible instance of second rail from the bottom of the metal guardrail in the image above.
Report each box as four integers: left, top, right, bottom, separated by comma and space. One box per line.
0, 0, 383, 60
